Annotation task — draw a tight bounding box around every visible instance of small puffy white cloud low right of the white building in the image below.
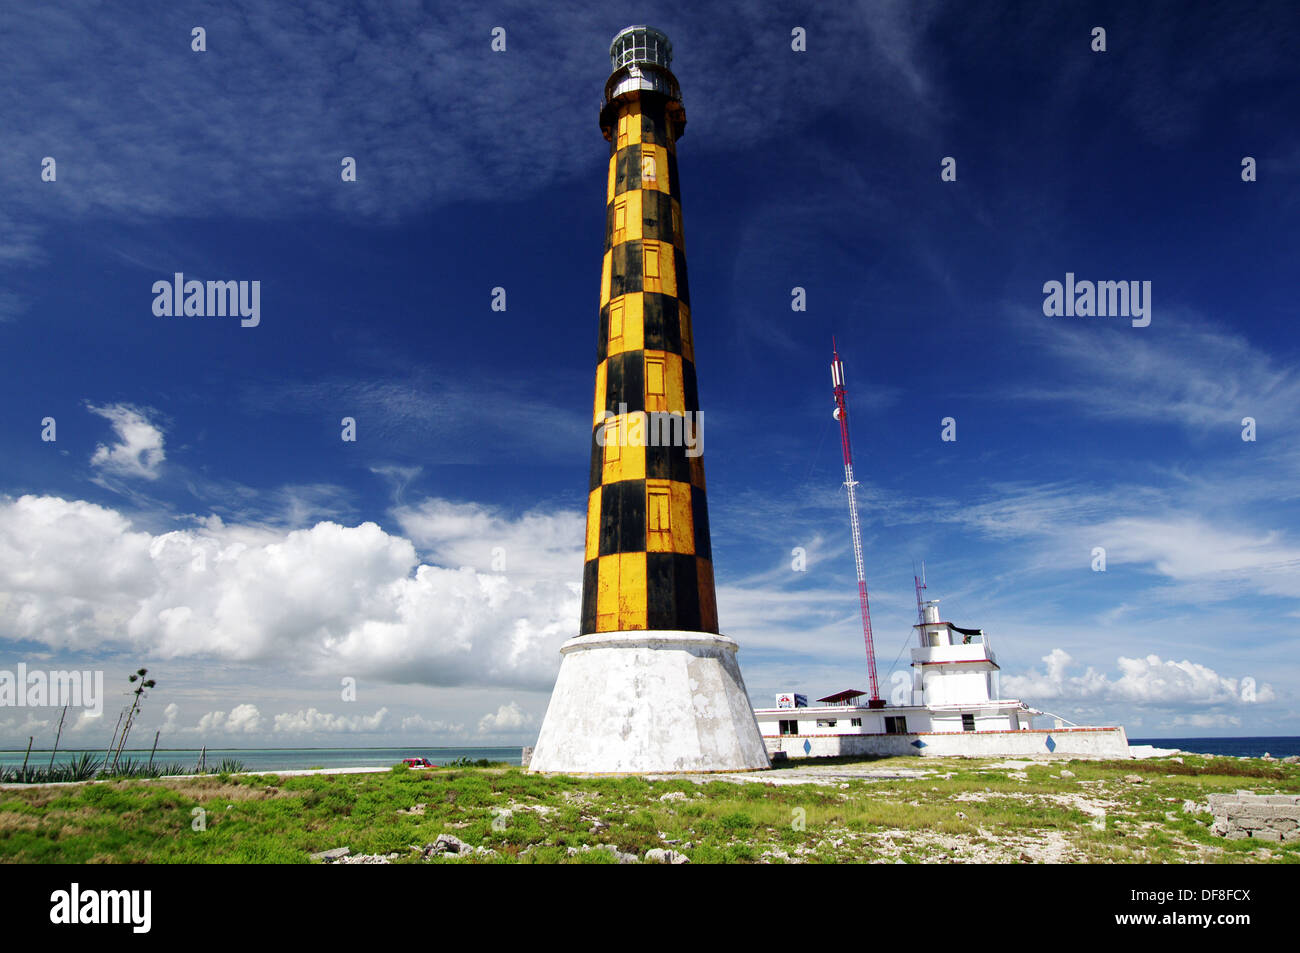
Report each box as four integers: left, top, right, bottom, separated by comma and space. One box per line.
1002, 649, 1277, 706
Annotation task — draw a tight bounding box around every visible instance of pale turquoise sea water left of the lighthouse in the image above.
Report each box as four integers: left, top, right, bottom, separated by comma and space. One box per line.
0, 745, 521, 771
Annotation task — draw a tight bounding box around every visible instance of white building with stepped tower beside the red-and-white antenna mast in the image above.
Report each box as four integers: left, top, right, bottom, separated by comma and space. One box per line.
754, 599, 1128, 758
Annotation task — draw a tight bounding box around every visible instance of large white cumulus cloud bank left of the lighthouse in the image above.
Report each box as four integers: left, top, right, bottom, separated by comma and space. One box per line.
0, 495, 582, 690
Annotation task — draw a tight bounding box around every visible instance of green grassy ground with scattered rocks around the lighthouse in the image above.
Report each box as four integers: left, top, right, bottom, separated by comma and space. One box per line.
0, 755, 1300, 863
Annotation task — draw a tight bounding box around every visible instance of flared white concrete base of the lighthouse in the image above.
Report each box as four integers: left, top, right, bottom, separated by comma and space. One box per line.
529, 631, 771, 774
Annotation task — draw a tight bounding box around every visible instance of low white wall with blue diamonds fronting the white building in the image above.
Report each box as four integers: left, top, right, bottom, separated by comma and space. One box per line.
763, 728, 1128, 758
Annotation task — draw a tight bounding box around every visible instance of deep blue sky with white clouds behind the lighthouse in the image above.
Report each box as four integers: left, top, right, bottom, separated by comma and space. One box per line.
0, 0, 1300, 750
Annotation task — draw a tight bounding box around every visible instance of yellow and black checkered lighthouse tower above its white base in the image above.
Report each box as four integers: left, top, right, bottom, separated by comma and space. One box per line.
581, 26, 718, 634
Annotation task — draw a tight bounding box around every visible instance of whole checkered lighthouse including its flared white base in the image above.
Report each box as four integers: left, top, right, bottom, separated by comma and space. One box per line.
529, 26, 770, 774
